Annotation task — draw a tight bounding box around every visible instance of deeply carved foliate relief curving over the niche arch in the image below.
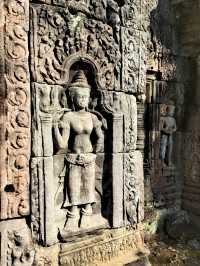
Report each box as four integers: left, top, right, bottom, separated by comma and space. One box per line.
32, 6, 121, 90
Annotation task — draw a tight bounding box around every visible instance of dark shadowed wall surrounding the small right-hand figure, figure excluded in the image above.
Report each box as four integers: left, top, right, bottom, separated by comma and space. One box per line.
147, 0, 200, 229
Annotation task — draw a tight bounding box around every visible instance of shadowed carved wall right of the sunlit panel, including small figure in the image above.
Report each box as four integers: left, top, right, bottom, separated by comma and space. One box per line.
144, 0, 200, 229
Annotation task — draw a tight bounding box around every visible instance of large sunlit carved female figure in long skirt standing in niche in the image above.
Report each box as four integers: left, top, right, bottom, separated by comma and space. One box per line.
54, 70, 104, 231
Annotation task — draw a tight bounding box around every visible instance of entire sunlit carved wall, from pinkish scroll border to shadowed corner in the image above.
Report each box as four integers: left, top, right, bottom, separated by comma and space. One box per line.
0, 0, 150, 266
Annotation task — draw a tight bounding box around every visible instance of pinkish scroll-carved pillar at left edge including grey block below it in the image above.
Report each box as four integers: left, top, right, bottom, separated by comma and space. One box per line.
0, 0, 34, 266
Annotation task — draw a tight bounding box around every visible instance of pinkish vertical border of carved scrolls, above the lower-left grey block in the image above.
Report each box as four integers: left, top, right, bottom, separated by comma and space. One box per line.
0, 0, 30, 219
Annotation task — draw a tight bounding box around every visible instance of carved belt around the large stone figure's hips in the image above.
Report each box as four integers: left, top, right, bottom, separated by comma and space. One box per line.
65, 153, 96, 167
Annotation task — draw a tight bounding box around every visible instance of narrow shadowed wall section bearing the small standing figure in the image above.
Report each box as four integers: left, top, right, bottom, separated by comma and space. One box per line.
146, 0, 188, 211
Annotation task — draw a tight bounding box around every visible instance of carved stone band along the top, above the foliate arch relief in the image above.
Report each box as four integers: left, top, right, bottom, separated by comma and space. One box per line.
29, 0, 147, 30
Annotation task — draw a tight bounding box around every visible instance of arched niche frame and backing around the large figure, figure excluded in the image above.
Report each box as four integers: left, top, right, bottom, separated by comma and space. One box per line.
31, 53, 137, 245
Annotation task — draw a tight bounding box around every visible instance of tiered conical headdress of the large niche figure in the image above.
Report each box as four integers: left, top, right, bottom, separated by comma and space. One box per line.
69, 70, 91, 92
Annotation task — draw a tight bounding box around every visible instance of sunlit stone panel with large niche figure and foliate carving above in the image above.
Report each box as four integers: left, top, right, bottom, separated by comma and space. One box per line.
27, 1, 146, 245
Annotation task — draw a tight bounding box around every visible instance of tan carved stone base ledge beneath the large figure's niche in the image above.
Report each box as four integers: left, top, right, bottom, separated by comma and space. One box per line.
59, 229, 143, 266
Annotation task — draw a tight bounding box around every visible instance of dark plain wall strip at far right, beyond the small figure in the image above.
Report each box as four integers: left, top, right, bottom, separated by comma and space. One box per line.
173, 1, 200, 227
